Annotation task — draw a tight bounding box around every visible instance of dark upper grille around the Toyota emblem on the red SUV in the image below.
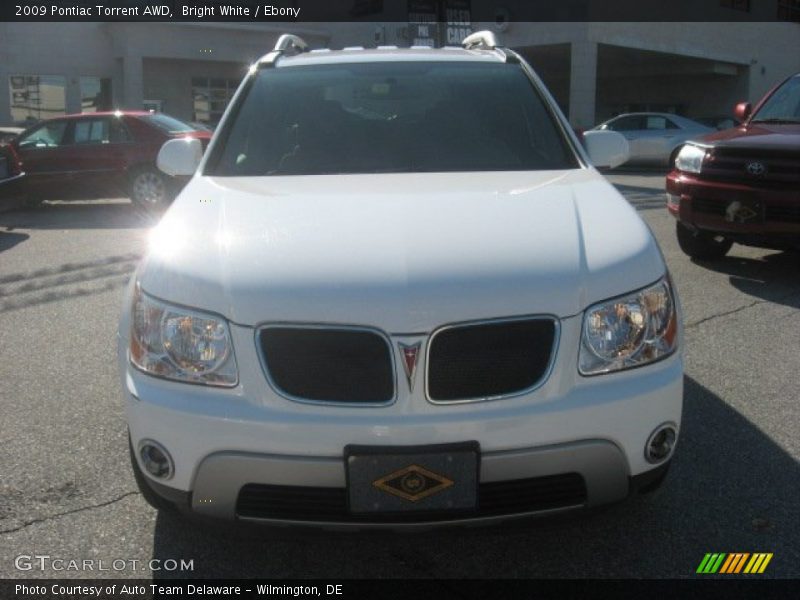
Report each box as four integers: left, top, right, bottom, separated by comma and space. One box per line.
702, 148, 800, 189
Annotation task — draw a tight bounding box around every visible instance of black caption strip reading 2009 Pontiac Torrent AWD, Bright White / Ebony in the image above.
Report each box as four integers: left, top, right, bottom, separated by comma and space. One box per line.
0, 0, 800, 24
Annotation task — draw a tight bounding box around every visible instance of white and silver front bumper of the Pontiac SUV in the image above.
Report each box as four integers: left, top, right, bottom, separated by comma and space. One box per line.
120, 316, 683, 528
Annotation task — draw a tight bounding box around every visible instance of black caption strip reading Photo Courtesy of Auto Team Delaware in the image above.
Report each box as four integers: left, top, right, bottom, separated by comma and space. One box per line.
0, 576, 800, 600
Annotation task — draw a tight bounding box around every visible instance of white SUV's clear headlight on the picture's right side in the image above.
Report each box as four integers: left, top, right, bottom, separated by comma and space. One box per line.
578, 279, 678, 375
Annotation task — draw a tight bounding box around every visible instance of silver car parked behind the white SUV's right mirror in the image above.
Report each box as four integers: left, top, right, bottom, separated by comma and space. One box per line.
595, 113, 713, 166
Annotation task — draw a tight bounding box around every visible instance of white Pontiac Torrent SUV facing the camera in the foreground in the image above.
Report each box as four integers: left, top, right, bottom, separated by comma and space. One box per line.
119, 33, 683, 528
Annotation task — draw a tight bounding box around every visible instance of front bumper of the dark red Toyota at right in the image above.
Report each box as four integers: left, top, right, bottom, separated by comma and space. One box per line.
666, 171, 800, 241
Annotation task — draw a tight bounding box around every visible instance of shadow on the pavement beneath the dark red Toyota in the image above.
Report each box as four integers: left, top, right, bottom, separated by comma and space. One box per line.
694, 251, 800, 308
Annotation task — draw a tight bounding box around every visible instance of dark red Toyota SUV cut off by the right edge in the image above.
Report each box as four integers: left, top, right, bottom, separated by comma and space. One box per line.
667, 73, 800, 259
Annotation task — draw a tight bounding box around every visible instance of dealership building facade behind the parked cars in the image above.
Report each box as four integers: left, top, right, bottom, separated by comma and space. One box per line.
0, 17, 800, 128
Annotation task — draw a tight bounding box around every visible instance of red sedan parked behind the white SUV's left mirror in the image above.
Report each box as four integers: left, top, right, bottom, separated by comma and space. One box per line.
0, 111, 211, 207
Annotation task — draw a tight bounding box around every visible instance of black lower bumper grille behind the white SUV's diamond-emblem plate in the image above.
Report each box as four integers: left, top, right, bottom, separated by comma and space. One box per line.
236, 473, 586, 523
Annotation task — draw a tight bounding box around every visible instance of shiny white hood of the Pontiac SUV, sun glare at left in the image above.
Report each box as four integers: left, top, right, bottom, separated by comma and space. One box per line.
138, 169, 665, 333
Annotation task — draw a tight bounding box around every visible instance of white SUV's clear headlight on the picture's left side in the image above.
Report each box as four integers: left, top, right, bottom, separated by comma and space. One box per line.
130, 286, 238, 387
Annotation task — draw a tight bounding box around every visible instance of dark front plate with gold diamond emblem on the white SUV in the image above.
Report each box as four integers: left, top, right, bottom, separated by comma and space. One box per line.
345, 442, 479, 513
